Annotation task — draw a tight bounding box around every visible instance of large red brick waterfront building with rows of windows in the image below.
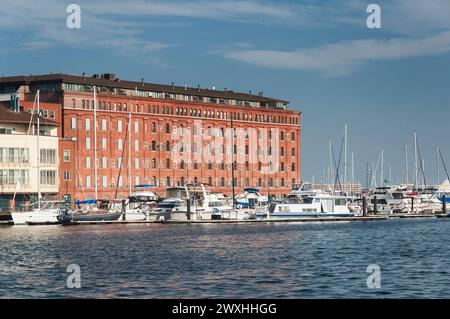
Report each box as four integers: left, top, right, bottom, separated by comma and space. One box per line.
0, 74, 301, 199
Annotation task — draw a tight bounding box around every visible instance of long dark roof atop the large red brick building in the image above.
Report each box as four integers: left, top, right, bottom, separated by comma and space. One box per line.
0, 73, 289, 103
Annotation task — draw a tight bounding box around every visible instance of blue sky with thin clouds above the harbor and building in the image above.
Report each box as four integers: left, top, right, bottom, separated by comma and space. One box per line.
0, 0, 450, 184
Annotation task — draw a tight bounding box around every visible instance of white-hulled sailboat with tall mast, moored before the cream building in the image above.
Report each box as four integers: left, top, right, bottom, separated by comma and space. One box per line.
11, 90, 61, 225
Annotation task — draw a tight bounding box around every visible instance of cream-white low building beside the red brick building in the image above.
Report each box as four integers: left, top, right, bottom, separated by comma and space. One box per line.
0, 102, 59, 211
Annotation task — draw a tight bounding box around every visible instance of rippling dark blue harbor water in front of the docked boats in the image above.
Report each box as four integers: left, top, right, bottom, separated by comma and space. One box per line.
0, 219, 450, 298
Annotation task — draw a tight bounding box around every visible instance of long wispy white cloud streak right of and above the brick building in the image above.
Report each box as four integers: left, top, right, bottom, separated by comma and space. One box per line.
223, 31, 450, 76
